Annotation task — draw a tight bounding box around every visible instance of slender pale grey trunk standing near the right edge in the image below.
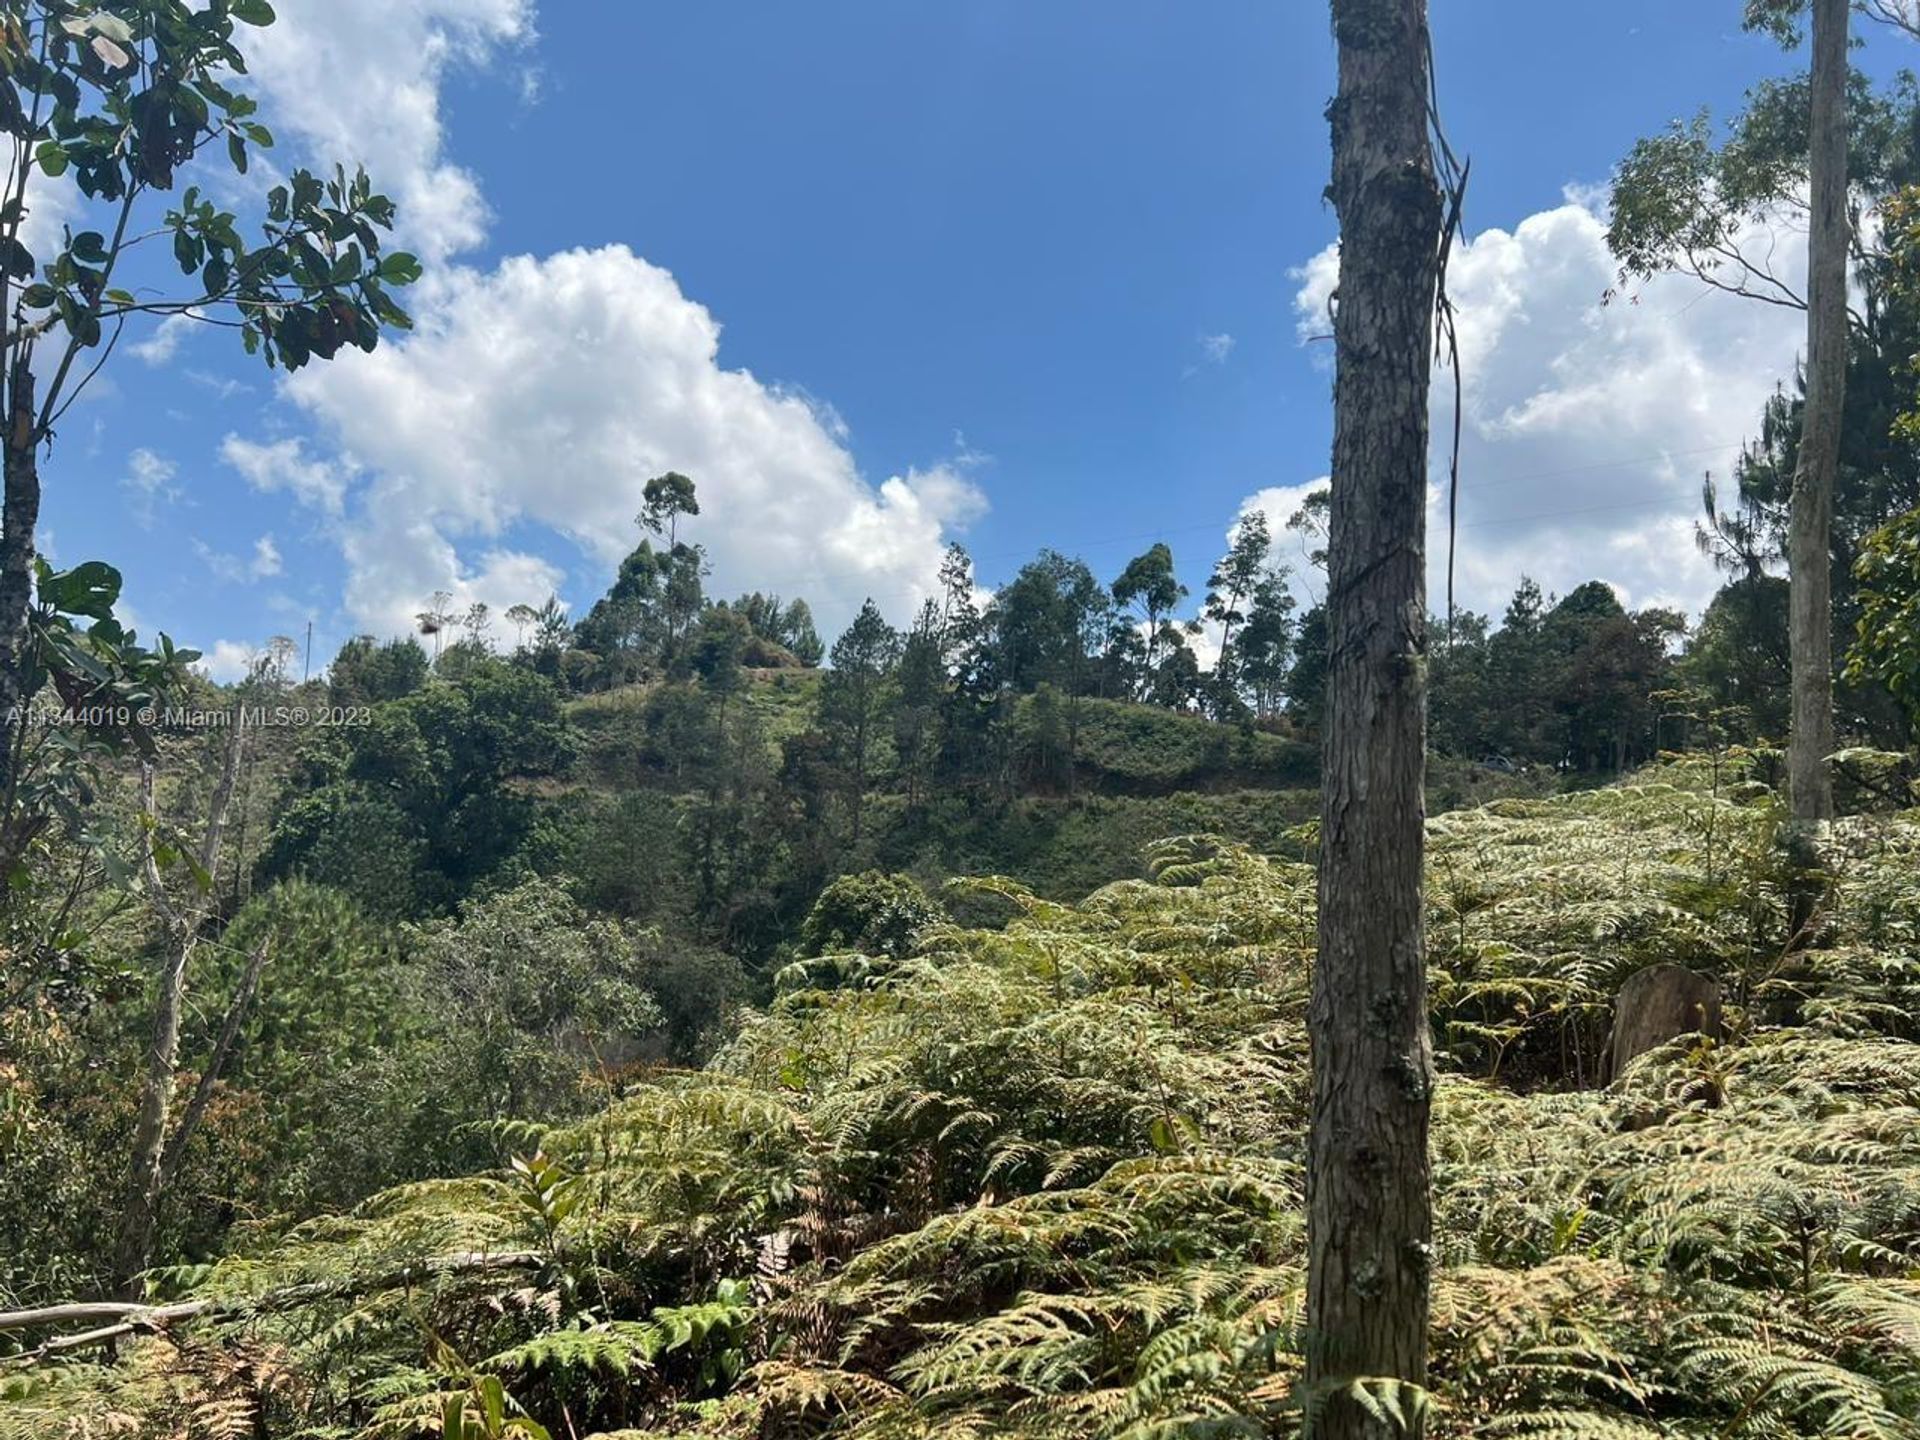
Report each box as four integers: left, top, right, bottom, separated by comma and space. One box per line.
1788, 0, 1847, 826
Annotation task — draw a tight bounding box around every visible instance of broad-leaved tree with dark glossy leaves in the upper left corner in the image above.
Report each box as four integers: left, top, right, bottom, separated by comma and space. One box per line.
0, 0, 420, 791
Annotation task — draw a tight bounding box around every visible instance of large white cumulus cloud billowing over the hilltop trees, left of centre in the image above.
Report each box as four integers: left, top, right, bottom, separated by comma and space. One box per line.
255, 246, 985, 634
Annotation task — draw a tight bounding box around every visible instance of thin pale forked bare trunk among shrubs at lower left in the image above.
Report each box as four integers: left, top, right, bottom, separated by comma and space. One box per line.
113, 721, 246, 1300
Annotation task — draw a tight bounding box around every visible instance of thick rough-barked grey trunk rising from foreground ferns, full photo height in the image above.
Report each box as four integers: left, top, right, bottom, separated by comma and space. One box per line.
1306, 0, 1442, 1440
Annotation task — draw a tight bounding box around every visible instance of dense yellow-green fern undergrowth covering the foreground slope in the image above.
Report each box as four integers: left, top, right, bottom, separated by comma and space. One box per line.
11, 756, 1920, 1440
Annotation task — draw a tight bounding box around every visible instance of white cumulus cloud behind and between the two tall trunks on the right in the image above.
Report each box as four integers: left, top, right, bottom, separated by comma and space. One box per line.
1275, 192, 1805, 616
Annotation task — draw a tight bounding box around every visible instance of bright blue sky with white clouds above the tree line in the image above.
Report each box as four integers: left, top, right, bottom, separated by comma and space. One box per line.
30, 0, 1905, 672
